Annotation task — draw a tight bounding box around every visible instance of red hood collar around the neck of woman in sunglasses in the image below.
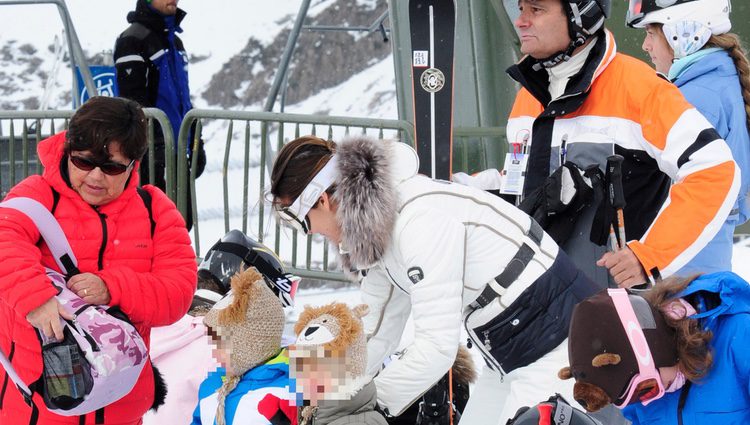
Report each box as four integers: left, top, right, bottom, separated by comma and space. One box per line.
37, 132, 140, 214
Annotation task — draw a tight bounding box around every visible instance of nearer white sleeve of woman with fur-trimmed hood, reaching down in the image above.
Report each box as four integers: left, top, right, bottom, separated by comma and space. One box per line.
375, 210, 465, 415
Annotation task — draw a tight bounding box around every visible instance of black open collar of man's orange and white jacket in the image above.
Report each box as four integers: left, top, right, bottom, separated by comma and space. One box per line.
506, 29, 617, 110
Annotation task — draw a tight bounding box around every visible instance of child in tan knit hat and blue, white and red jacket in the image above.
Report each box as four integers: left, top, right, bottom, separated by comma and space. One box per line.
192, 268, 297, 425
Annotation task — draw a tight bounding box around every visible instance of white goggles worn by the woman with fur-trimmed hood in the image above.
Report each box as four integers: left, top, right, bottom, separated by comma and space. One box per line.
275, 155, 338, 235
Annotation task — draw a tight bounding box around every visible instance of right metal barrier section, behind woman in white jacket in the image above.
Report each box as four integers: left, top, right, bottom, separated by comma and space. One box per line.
176, 110, 505, 281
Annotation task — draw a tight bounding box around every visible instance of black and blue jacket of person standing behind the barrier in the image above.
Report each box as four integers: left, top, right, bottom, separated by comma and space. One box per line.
114, 0, 193, 144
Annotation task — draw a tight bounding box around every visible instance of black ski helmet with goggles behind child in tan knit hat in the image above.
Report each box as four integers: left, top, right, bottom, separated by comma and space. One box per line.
198, 230, 299, 307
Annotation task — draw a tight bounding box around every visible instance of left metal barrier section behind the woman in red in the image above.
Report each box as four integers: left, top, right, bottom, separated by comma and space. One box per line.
0, 108, 175, 199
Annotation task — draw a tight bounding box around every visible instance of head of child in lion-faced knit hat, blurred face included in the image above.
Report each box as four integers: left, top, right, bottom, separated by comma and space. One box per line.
289, 303, 368, 400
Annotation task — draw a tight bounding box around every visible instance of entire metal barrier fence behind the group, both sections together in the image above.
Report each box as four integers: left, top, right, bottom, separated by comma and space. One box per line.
0, 108, 505, 281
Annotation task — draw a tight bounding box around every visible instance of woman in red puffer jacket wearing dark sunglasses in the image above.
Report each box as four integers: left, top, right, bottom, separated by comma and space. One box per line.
0, 97, 196, 424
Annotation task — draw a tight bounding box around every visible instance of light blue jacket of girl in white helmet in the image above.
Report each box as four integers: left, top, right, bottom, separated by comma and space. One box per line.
674, 50, 750, 276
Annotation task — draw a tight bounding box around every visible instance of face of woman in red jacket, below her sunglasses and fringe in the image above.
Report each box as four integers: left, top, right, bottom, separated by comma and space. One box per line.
68, 143, 135, 206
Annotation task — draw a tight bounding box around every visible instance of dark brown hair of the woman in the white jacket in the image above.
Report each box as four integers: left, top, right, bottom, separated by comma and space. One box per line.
271, 136, 336, 202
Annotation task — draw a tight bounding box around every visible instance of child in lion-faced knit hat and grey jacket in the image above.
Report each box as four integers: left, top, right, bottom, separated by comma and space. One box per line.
289, 303, 387, 425
